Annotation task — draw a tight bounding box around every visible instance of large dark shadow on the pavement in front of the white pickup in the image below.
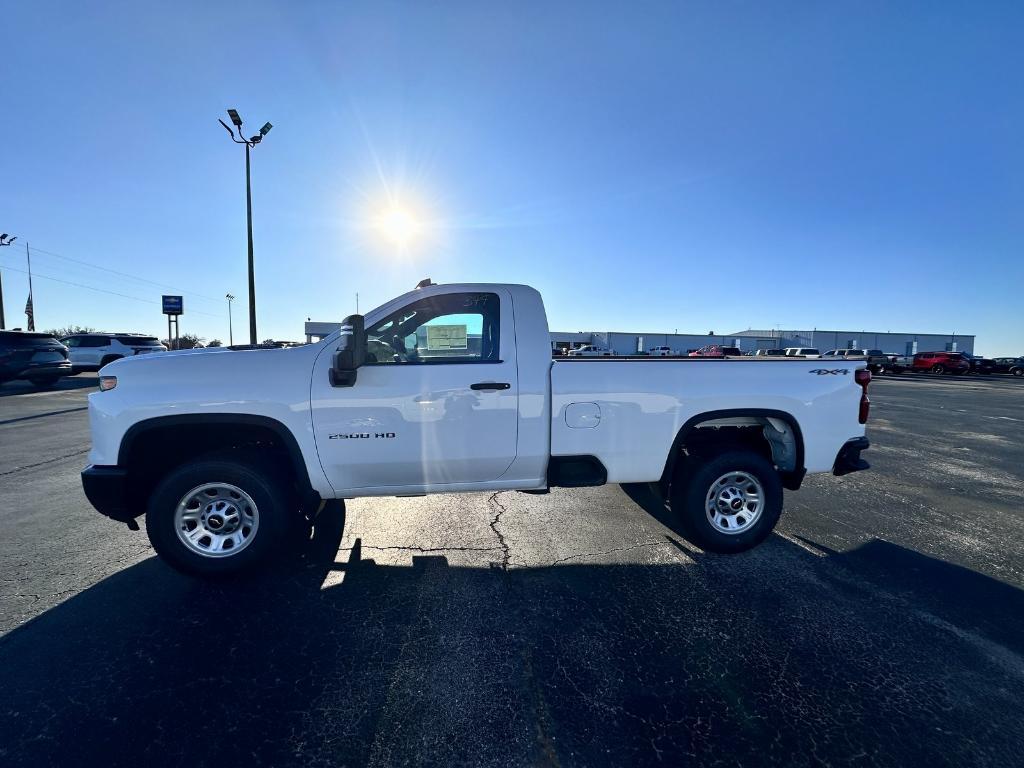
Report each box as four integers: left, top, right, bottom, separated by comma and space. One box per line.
0, 501, 1024, 766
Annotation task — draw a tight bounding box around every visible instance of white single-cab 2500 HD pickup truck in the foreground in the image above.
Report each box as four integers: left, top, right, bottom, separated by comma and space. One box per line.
82, 282, 870, 574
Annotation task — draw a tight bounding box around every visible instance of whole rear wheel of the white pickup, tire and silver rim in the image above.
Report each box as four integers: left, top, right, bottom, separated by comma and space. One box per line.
670, 451, 782, 553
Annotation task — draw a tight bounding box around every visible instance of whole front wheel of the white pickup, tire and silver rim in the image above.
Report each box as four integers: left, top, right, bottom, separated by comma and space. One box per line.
145, 457, 298, 575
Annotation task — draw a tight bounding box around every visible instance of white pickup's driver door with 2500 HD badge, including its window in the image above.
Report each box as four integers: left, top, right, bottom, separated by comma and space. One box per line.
310, 287, 519, 492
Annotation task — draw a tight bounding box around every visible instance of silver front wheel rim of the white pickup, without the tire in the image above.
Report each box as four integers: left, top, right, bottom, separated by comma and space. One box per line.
174, 482, 259, 557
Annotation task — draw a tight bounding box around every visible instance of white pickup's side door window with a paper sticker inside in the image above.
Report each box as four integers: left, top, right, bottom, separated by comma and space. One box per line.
367, 293, 501, 365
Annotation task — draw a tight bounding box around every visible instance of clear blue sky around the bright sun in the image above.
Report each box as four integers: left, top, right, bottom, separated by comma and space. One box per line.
0, 2, 1024, 354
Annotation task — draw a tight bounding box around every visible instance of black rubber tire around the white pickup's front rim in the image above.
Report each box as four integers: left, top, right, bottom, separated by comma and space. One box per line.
145, 453, 301, 577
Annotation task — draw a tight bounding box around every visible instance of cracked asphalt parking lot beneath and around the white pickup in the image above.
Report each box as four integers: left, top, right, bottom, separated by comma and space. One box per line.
0, 376, 1024, 767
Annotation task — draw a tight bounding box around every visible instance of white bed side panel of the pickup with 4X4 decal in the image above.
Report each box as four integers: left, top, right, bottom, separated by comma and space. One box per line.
551, 356, 864, 482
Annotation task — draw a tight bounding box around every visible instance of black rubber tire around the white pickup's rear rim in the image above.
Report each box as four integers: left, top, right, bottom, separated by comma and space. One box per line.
669, 450, 782, 554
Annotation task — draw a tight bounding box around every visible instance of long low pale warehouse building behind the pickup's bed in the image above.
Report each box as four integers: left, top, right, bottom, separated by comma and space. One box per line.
551, 329, 975, 354
